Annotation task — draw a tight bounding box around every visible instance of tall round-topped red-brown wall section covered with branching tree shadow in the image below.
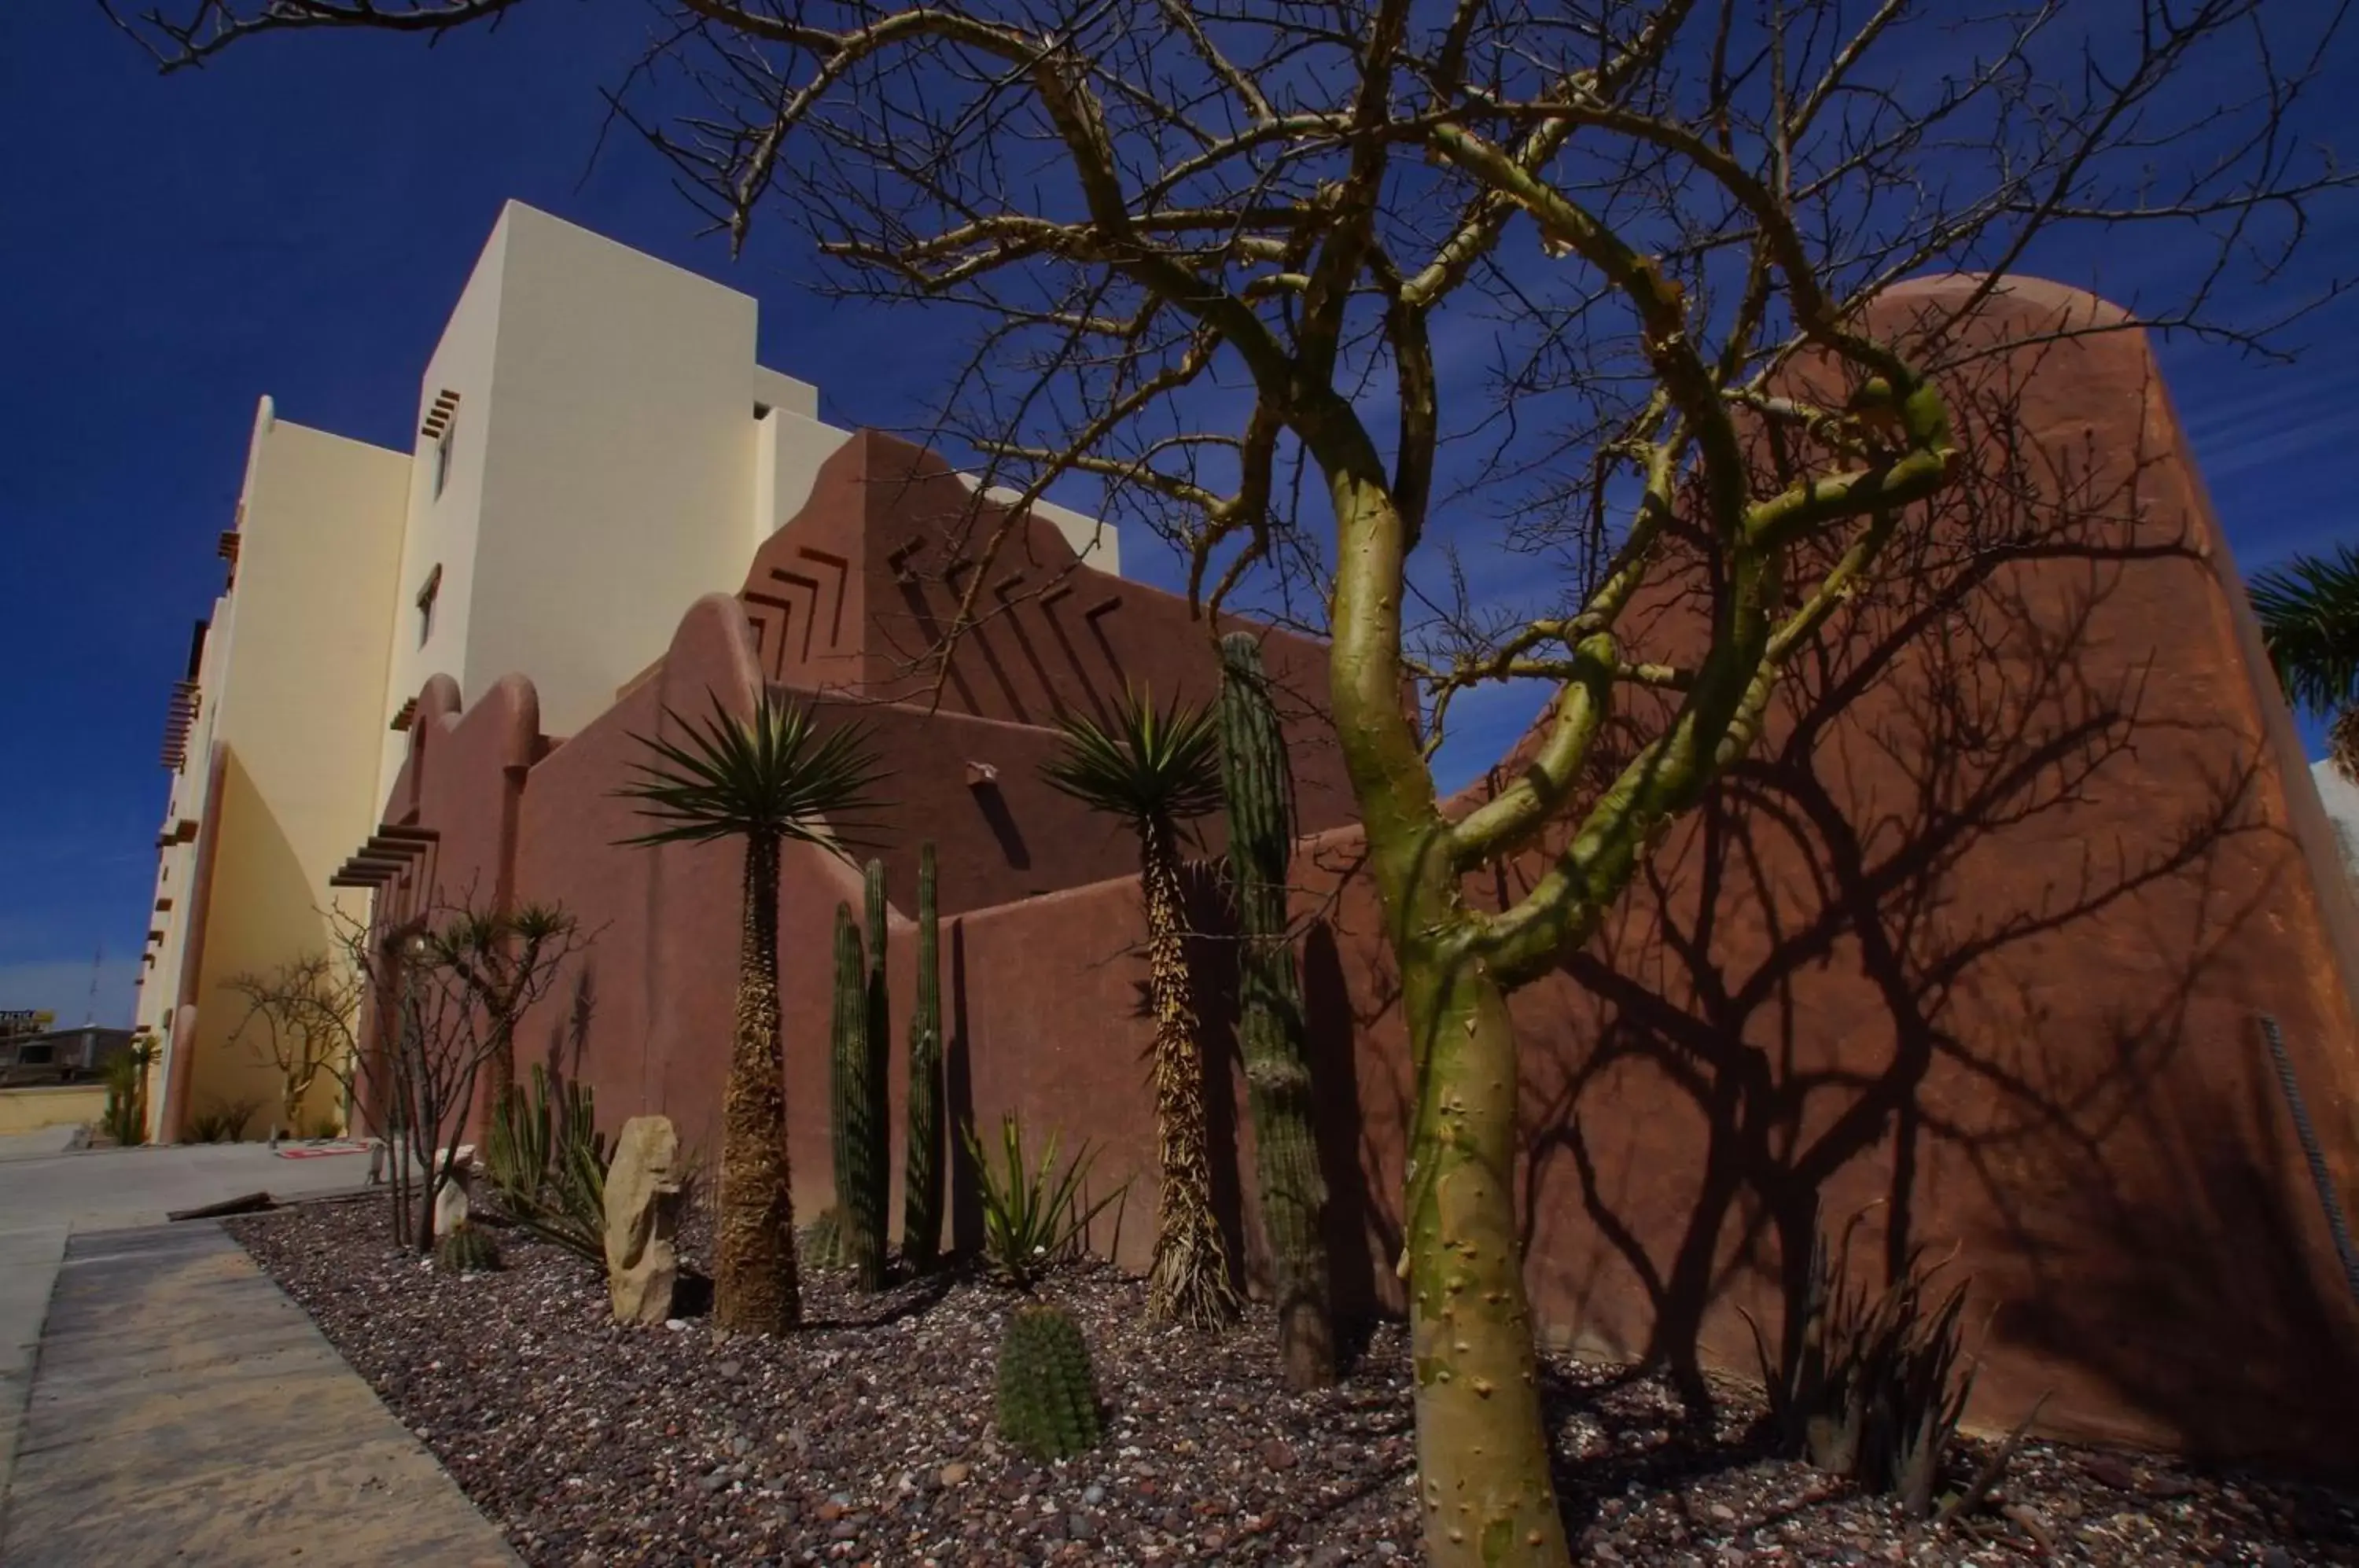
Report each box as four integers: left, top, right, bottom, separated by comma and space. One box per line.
1406, 283, 2359, 1464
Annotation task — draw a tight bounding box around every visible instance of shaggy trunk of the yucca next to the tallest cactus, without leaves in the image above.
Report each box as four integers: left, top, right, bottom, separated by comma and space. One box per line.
1139, 823, 1236, 1327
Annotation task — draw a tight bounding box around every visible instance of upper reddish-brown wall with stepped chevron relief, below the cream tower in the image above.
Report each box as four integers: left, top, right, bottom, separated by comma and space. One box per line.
736, 432, 1352, 912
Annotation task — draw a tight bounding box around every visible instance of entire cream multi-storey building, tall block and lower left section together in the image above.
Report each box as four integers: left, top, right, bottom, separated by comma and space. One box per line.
137, 203, 1118, 1139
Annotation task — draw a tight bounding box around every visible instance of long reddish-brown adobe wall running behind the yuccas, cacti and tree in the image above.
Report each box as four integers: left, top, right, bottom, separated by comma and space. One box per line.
359, 283, 2359, 1469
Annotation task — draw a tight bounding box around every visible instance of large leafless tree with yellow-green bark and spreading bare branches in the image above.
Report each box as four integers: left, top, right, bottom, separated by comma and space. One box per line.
101, 0, 2347, 1563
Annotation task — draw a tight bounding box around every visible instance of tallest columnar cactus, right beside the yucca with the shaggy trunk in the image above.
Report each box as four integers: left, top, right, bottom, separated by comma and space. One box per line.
1220, 632, 1335, 1389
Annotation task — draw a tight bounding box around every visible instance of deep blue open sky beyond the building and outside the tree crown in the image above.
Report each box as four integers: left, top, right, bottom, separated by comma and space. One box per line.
0, 0, 2359, 1021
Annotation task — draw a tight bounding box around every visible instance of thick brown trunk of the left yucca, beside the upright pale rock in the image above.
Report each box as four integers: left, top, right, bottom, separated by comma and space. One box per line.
712, 834, 802, 1334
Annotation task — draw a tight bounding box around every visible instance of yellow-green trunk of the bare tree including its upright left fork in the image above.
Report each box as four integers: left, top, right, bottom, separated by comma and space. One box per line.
1297, 424, 1571, 1568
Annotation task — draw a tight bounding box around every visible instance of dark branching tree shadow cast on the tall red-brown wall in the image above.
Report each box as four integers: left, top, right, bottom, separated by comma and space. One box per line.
1498, 358, 2352, 1448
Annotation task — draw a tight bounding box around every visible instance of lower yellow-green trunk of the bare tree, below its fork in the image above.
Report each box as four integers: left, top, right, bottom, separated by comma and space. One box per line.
1401, 943, 1571, 1568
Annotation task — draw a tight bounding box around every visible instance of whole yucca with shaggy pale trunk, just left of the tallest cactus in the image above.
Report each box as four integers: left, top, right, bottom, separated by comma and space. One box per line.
1040, 691, 1236, 1325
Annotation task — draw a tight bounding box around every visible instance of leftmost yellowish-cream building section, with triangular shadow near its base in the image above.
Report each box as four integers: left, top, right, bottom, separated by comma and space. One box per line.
134, 399, 408, 1136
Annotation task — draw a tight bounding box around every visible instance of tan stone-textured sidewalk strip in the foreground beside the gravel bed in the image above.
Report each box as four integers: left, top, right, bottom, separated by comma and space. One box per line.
0, 1221, 517, 1568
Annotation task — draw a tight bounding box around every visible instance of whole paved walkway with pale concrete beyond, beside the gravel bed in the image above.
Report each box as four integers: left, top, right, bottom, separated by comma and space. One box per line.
0, 1146, 517, 1568
